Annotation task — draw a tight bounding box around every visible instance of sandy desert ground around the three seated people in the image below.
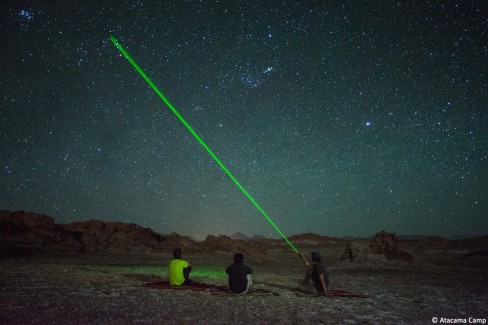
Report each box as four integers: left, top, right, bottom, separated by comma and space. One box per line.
0, 244, 488, 324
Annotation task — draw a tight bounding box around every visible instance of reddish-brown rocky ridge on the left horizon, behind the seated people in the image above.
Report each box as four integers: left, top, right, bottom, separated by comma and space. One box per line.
0, 211, 282, 261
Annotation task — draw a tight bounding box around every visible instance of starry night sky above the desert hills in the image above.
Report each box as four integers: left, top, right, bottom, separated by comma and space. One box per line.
0, 0, 488, 238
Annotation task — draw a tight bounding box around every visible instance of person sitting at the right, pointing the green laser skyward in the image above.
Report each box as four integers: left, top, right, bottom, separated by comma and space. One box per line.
298, 252, 329, 296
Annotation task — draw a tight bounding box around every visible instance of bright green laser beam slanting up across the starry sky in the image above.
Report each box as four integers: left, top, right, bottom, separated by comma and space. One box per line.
110, 35, 299, 253
